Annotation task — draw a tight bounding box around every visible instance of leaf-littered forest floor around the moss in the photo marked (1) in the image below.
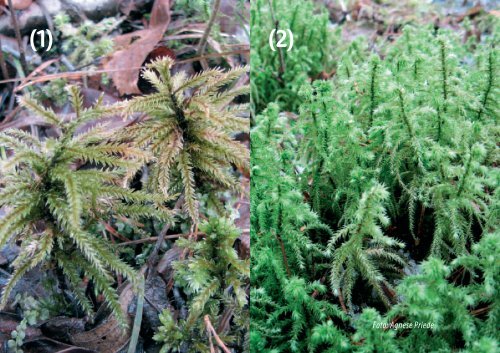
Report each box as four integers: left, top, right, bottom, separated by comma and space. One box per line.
0, 0, 250, 353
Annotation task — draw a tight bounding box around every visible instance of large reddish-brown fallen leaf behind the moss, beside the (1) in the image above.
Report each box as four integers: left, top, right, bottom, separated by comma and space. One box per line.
104, 0, 170, 95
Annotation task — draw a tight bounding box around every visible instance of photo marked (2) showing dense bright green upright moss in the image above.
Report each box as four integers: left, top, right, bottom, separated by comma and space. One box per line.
250, 0, 500, 353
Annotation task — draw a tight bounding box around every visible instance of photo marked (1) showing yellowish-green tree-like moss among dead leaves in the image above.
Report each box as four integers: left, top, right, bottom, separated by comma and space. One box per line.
0, 0, 250, 353
